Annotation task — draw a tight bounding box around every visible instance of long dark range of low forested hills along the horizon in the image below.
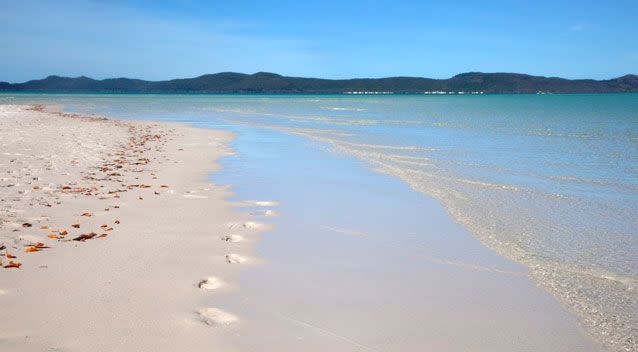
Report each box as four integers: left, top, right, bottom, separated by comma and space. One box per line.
0, 72, 638, 94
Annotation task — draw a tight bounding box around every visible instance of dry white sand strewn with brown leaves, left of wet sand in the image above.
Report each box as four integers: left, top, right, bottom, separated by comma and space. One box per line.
0, 105, 275, 352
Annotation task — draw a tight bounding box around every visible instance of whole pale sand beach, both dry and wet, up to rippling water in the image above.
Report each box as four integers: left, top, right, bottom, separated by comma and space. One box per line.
0, 104, 616, 352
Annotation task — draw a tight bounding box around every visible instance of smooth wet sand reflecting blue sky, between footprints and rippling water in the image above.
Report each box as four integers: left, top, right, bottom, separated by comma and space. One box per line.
195, 119, 601, 352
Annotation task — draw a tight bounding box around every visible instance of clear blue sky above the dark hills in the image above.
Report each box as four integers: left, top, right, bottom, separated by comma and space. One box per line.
0, 0, 638, 82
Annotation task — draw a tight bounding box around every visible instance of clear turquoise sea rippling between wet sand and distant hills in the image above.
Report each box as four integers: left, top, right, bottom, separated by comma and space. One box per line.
0, 94, 638, 351
